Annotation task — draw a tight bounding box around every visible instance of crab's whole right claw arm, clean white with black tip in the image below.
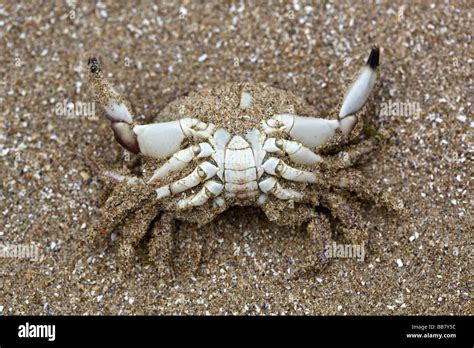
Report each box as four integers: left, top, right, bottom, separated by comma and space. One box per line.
261, 47, 379, 149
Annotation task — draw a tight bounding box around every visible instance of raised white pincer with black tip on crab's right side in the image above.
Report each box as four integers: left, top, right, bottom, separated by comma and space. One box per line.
339, 46, 380, 135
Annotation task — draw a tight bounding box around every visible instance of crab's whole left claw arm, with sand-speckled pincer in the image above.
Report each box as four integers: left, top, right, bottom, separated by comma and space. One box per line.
88, 58, 214, 158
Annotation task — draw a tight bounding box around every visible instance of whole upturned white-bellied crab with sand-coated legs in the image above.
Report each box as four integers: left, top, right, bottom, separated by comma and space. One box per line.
88, 47, 398, 274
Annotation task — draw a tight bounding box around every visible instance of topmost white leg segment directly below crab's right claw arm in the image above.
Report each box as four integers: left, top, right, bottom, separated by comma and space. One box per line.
263, 138, 321, 165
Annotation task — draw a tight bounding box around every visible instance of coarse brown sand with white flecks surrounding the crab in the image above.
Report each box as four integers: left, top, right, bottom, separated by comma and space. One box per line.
0, 1, 474, 315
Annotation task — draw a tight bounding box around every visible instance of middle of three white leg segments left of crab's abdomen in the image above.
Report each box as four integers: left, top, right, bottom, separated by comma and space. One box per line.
156, 162, 219, 199
